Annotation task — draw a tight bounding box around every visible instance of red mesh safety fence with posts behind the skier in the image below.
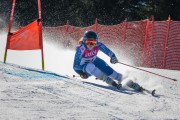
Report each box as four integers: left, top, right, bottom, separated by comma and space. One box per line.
43, 19, 180, 70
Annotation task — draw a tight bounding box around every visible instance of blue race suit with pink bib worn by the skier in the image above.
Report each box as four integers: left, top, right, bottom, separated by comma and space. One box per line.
73, 42, 122, 80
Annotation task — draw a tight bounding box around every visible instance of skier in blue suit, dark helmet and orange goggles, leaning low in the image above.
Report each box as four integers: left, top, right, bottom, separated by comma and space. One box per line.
73, 30, 140, 89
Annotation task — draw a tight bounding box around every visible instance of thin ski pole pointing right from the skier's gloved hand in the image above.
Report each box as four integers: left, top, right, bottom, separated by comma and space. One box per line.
117, 62, 177, 81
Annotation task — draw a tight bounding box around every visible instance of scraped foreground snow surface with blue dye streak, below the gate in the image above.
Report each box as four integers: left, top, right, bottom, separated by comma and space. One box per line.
0, 62, 180, 120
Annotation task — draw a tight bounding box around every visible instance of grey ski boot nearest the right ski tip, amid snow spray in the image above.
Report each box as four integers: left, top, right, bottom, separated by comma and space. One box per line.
126, 80, 144, 92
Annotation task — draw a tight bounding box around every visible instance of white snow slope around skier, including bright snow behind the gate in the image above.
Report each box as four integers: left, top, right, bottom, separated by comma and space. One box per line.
0, 29, 180, 120
